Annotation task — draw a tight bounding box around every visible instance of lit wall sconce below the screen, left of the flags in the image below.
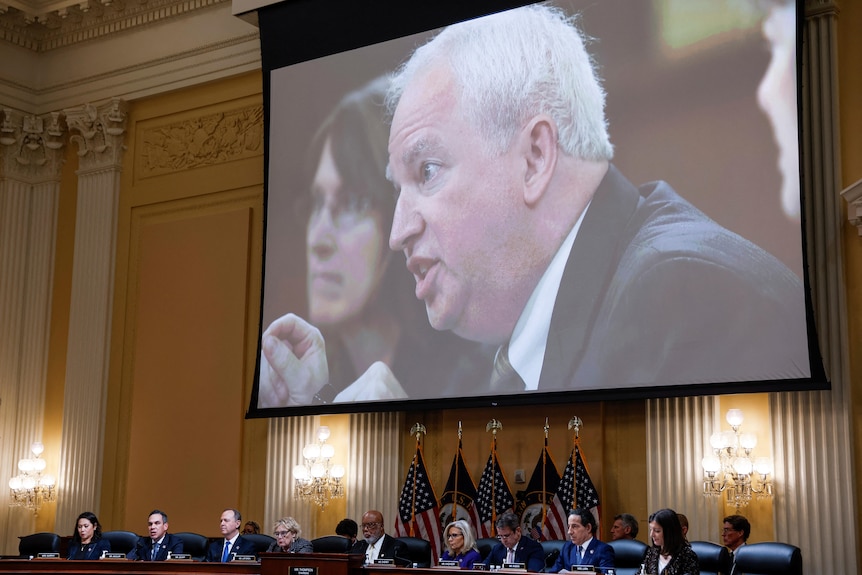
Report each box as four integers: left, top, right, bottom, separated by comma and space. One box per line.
293, 425, 344, 509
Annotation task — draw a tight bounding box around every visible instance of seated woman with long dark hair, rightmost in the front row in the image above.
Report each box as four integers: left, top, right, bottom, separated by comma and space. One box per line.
643, 509, 700, 575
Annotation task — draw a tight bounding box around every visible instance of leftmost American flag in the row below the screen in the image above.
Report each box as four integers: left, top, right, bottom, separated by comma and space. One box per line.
395, 445, 442, 561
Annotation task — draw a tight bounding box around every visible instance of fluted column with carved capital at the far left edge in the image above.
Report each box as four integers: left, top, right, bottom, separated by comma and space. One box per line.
0, 109, 64, 553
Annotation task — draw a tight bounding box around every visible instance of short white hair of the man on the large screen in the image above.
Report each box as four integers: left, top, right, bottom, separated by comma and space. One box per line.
386, 5, 613, 161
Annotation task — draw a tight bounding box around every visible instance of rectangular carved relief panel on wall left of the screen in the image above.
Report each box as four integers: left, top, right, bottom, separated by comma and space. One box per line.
140, 105, 263, 178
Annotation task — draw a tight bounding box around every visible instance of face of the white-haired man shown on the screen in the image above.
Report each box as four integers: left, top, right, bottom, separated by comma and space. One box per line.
389, 66, 535, 343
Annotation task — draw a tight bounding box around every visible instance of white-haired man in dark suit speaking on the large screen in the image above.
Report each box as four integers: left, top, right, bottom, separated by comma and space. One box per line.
387, 0, 807, 395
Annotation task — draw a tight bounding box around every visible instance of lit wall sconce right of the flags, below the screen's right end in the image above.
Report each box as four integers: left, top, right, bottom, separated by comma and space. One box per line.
701, 409, 773, 510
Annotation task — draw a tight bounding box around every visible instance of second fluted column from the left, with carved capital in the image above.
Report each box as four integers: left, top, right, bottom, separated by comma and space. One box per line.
56, 100, 126, 528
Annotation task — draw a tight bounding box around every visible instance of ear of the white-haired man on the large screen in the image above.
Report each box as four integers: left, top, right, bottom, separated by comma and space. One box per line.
521, 114, 559, 206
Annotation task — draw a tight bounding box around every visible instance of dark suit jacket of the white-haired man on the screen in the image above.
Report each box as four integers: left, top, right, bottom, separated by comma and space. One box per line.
539, 166, 808, 391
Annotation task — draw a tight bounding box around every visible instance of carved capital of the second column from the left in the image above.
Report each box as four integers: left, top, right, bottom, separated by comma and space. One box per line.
64, 98, 128, 170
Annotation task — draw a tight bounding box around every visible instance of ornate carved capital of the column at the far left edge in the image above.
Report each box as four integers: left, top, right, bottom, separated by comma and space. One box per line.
0, 108, 66, 183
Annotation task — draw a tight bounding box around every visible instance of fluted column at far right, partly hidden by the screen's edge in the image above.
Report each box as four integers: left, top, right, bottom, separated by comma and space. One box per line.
770, 0, 859, 573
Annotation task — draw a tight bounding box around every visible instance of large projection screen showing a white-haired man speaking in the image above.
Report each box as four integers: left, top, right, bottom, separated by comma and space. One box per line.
248, 0, 829, 417
